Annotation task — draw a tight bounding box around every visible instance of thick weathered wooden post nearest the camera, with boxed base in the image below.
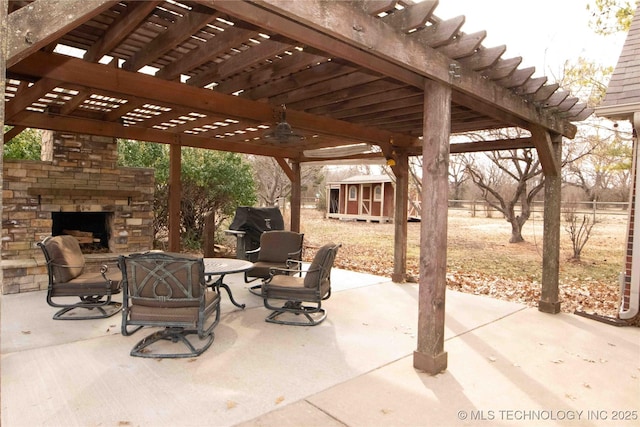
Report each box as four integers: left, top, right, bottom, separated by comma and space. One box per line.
413, 80, 451, 375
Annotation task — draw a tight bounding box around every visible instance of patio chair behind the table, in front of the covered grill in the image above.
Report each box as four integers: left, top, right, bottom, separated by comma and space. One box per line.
244, 230, 304, 296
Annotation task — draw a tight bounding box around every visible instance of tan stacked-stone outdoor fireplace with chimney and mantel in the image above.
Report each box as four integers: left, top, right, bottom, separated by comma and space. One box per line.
2, 133, 154, 294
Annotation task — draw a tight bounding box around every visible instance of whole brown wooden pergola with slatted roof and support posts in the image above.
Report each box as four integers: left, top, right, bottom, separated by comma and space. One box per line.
0, 0, 591, 373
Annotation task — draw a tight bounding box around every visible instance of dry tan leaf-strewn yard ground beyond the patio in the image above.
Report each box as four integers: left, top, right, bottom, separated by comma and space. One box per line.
285, 209, 627, 317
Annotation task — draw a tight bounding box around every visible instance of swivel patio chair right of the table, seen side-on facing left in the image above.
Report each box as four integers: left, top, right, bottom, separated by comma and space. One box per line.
262, 243, 341, 326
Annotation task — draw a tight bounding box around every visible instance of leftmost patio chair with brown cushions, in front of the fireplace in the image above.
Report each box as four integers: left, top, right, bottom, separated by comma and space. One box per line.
38, 235, 122, 320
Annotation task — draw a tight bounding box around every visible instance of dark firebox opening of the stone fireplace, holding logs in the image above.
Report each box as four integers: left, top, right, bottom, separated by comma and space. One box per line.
51, 212, 113, 253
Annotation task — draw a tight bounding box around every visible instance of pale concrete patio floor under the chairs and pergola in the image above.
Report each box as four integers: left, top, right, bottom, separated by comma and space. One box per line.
1, 269, 640, 427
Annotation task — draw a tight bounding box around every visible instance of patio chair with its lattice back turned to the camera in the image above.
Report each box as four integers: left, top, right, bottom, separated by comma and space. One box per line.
118, 252, 220, 358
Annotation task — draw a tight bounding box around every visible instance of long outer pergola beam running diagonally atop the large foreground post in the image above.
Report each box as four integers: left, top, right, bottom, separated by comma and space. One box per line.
241, 0, 576, 138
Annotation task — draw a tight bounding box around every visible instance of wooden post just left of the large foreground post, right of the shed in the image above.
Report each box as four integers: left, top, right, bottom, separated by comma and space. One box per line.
392, 151, 409, 283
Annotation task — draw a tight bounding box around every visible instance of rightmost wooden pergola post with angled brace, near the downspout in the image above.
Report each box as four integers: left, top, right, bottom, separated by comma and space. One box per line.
538, 135, 562, 314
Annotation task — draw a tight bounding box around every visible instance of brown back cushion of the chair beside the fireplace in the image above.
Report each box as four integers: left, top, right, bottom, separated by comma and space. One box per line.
46, 235, 85, 283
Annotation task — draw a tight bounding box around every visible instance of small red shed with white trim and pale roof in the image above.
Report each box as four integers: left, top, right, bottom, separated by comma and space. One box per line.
327, 175, 395, 222
